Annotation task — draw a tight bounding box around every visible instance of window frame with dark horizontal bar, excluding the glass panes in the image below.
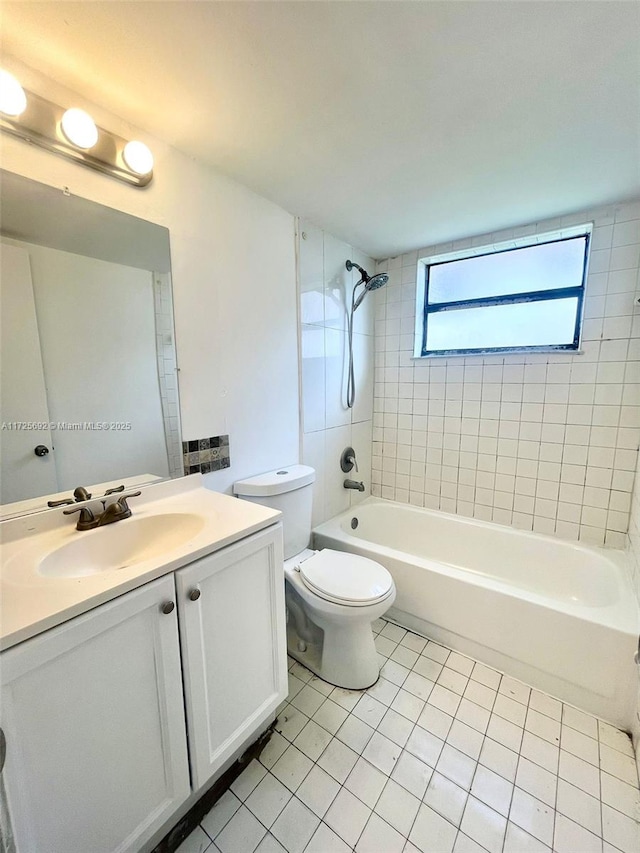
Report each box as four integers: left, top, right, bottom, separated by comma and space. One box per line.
415, 228, 592, 358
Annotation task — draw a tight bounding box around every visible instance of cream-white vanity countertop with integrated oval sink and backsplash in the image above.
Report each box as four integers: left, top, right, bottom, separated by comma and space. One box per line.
0, 474, 280, 649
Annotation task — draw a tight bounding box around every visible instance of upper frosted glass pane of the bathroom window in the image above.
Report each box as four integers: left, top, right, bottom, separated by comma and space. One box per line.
427, 236, 586, 305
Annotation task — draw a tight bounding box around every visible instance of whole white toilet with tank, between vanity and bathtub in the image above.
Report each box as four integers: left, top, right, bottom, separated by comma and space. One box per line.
233, 465, 396, 690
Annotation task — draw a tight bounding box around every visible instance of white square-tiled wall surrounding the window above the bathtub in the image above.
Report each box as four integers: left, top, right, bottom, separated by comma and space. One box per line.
372, 202, 640, 547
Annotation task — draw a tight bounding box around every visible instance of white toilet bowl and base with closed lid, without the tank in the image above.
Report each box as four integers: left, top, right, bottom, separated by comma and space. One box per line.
285, 549, 396, 690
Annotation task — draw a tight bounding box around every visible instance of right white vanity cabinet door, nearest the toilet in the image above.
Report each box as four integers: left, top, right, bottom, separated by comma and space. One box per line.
176, 524, 287, 789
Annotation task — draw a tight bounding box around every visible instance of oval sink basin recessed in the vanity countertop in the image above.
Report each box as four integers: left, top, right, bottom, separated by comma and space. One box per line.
37, 512, 205, 578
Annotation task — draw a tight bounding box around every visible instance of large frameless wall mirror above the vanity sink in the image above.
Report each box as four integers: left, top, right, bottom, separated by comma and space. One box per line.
0, 171, 184, 517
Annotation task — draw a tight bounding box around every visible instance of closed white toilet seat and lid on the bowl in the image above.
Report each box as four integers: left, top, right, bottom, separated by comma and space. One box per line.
296, 548, 394, 607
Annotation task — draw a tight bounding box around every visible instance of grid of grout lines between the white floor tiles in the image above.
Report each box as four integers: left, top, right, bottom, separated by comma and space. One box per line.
190, 622, 634, 853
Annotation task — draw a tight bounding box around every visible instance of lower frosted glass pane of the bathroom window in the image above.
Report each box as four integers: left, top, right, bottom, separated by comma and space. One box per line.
425, 297, 579, 352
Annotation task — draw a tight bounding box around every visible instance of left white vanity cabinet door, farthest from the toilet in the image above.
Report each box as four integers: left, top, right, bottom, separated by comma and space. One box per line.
1, 575, 190, 853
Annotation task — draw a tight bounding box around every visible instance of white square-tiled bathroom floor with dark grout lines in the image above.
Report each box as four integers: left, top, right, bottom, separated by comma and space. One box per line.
179, 620, 640, 853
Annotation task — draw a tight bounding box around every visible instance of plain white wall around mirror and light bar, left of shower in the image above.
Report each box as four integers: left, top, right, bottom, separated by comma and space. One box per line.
0, 57, 299, 490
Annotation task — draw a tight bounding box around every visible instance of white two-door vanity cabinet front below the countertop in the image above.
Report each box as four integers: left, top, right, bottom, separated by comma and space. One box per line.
0, 524, 287, 853
